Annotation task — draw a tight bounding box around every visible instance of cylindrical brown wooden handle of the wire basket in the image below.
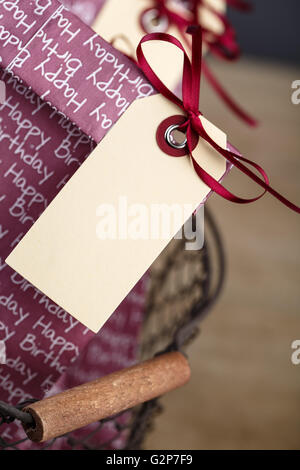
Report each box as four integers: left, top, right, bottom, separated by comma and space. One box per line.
24, 352, 191, 442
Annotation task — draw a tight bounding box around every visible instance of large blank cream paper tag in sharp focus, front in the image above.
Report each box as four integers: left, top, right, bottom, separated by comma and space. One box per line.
6, 95, 226, 332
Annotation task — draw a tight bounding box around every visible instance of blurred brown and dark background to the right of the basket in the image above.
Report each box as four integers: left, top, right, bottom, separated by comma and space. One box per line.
146, 0, 300, 449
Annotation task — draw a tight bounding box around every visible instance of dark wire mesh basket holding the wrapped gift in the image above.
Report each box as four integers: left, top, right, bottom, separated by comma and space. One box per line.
0, 207, 224, 450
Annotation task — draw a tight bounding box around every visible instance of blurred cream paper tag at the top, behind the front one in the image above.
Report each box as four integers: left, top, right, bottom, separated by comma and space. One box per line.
93, 0, 225, 89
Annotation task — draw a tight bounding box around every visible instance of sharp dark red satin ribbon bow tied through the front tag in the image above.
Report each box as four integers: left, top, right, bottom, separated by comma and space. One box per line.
137, 26, 300, 213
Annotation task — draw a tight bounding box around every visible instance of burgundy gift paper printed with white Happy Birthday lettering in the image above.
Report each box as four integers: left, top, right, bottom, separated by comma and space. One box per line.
0, 0, 153, 447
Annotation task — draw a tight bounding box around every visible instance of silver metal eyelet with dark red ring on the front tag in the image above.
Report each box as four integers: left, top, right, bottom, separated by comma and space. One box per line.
156, 114, 199, 157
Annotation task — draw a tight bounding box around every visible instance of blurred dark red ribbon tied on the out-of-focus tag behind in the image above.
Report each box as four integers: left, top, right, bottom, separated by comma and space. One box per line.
141, 0, 257, 126
